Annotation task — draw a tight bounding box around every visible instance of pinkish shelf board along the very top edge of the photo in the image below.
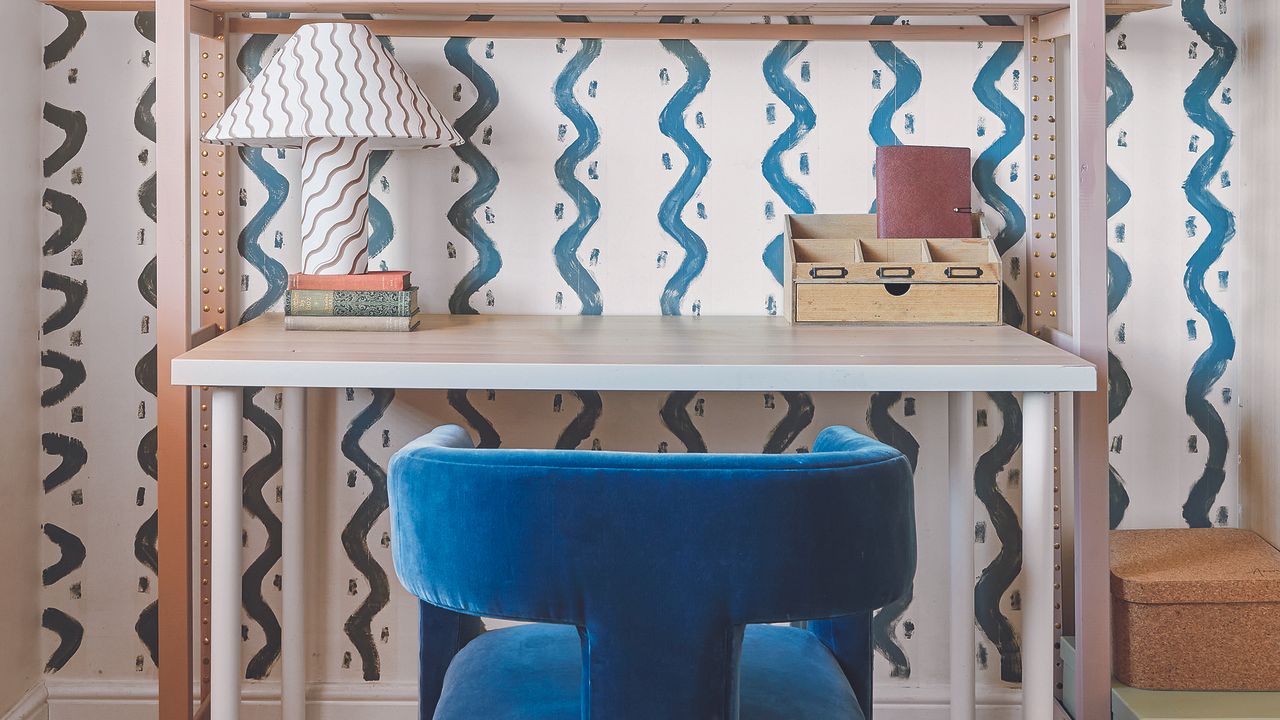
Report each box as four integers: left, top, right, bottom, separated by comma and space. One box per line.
45, 0, 1172, 17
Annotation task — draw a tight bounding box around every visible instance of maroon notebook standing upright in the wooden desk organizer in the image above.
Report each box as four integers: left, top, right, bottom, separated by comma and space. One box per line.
876, 145, 973, 237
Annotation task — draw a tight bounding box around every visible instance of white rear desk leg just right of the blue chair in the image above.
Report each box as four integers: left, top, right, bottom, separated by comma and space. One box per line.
947, 392, 977, 720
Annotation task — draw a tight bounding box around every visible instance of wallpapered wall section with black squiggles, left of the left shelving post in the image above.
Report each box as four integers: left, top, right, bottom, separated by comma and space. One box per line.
38, 6, 156, 691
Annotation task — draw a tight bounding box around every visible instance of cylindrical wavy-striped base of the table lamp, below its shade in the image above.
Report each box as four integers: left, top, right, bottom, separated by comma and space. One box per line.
302, 137, 369, 275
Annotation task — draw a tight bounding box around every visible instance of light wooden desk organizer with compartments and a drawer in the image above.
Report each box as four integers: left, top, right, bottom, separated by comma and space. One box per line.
782, 213, 1002, 325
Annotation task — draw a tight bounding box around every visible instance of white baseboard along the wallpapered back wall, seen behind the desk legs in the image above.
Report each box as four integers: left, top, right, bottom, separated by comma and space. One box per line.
37, 678, 1021, 720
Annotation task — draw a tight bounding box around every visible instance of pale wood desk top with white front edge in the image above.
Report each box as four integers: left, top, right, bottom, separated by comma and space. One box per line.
173, 315, 1097, 392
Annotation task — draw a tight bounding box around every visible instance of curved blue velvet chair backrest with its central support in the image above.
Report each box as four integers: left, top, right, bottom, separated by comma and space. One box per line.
389, 427, 915, 719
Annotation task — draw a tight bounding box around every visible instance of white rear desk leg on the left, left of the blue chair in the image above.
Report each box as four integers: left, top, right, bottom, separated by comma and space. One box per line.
280, 387, 307, 720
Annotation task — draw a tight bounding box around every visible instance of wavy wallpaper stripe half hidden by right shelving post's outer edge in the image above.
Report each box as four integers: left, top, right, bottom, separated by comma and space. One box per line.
1107, 15, 1133, 529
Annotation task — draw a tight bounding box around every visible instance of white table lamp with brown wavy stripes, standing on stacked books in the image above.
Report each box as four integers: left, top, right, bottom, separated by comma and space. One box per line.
204, 23, 462, 274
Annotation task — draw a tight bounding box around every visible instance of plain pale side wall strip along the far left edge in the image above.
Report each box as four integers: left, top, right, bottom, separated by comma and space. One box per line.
0, 0, 41, 711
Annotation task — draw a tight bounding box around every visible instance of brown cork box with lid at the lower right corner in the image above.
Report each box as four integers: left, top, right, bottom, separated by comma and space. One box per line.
1111, 528, 1280, 691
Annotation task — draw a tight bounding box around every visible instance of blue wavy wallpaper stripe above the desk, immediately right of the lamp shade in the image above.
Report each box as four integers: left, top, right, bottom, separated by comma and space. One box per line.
444, 15, 502, 315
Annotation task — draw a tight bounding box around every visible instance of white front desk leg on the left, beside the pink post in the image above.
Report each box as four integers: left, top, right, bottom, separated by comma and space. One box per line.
209, 387, 244, 720
